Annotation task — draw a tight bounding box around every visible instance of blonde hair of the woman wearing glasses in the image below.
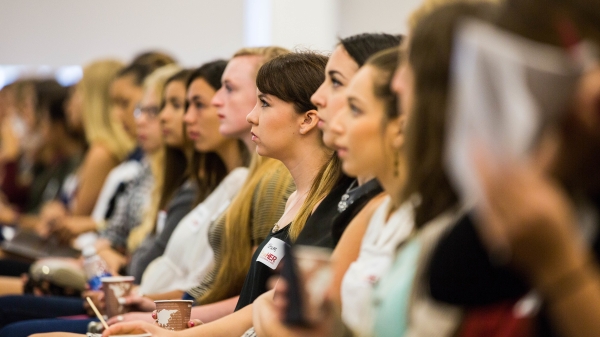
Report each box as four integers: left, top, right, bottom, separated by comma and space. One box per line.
127, 64, 181, 252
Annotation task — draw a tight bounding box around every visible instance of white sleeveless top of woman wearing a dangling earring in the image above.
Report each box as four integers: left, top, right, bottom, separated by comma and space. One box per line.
341, 196, 414, 336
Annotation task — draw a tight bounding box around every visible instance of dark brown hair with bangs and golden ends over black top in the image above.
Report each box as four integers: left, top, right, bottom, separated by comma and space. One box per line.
256, 52, 339, 240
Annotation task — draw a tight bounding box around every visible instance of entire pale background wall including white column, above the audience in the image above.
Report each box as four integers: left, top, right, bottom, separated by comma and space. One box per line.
0, 0, 422, 88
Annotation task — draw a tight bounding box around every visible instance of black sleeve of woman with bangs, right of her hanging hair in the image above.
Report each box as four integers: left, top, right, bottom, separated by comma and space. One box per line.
295, 176, 354, 249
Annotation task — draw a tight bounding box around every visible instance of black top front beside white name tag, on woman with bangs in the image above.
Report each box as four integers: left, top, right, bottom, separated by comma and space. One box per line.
235, 225, 290, 311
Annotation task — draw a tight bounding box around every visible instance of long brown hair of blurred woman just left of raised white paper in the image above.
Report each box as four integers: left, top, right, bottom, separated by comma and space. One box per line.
400, 3, 497, 228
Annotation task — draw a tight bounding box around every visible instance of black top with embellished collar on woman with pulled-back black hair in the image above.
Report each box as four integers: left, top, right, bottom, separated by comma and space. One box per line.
331, 179, 383, 246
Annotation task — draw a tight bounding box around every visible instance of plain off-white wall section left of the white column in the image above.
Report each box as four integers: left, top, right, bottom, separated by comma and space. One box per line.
0, 0, 244, 66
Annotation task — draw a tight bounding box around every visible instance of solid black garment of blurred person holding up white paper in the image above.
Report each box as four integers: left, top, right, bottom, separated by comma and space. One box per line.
428, 200, 600, 336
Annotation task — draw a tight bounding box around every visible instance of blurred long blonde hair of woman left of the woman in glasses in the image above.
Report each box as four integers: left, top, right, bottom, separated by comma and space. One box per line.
77, 60, 135, 161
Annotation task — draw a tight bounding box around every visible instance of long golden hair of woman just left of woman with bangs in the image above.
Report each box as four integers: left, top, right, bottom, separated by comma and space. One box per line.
199, 47, 290, 303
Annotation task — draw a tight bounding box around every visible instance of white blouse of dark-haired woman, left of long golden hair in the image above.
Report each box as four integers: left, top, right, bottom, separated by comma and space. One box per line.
140, 168, 248, 294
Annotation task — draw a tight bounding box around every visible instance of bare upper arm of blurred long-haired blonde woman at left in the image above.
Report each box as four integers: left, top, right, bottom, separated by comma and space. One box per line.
71, 144, 118, 215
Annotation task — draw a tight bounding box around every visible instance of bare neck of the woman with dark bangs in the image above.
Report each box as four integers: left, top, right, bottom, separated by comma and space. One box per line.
281, 146, 331, 195
